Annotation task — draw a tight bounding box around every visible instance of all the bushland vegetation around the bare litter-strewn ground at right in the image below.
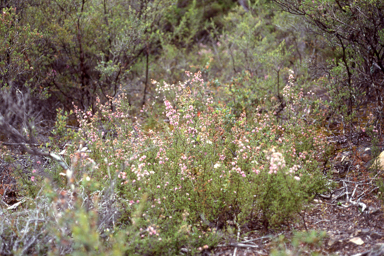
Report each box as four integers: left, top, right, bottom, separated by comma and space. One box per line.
0, 0, 384, 255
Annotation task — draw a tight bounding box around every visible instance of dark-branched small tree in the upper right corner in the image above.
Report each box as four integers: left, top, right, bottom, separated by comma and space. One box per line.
273, 0, 384, 118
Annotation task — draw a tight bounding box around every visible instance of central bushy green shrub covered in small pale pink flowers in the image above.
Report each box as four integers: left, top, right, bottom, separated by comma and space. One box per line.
68, 69, 325, 239
